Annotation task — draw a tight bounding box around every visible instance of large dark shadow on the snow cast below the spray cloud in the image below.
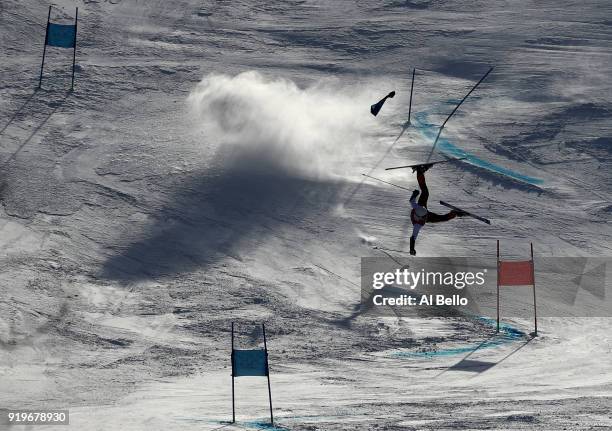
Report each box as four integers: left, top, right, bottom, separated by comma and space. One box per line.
102, 156, 339, 281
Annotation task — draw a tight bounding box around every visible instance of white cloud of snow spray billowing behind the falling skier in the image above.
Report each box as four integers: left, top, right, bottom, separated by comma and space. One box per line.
188, 71, 380, 179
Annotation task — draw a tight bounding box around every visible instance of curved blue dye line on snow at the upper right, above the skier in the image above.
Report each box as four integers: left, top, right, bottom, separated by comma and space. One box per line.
414, 109, 544, 186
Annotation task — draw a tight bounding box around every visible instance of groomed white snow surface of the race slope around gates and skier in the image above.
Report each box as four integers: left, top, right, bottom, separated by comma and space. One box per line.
0, 0, 612, 430
